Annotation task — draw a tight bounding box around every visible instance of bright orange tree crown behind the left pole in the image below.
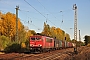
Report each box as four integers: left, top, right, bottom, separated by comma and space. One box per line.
1, 12, 22, 40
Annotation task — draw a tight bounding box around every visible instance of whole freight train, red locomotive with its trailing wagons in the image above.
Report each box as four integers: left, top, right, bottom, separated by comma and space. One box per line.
29, 35, 74, 52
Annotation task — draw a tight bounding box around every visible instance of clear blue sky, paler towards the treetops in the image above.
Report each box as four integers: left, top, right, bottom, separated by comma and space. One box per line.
0, 0, 90, 41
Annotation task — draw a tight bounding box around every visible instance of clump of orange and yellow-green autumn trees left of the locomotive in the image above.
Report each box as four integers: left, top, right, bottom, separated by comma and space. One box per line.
0, 12, 33, 50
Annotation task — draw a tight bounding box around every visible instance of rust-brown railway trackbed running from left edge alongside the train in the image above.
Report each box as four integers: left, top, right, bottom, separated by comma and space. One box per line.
0, 49, 73, 60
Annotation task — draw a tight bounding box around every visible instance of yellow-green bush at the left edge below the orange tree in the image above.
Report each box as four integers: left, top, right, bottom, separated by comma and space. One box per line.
0, 35, 11, 50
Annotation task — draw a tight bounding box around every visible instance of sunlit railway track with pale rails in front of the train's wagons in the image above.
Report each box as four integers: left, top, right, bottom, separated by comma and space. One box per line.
35, 50, 72, 60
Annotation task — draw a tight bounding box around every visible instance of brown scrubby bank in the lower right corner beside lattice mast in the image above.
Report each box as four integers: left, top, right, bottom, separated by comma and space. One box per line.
69, 46, 90, 60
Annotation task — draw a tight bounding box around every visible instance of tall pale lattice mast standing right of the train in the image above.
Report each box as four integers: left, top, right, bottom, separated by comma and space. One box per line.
73, 4, 77, 53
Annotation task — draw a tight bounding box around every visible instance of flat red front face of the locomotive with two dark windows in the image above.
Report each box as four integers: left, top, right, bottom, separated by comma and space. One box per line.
30, 36, 42, 51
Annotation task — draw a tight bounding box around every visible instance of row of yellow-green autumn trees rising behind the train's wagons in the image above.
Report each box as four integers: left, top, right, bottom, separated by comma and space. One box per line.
41, 22, 70, 41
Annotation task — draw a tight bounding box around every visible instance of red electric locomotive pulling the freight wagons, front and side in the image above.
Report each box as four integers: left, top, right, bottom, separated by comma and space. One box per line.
30, 35, 54, 51
